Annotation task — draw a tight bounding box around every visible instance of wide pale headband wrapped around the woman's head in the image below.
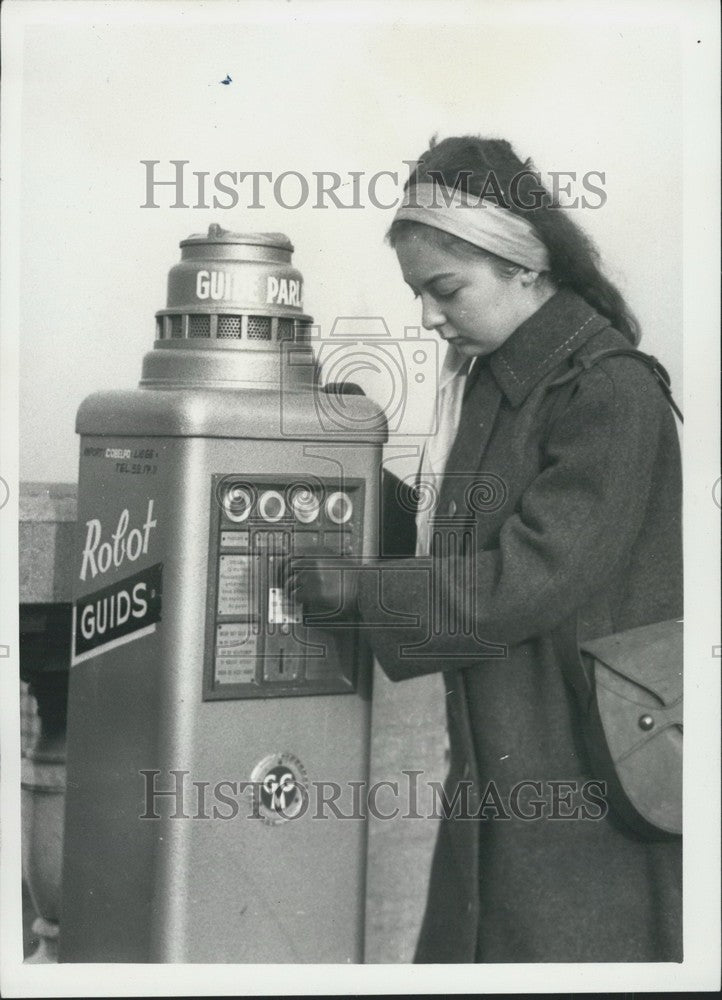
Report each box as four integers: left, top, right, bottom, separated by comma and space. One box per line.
394, 183, 549, 271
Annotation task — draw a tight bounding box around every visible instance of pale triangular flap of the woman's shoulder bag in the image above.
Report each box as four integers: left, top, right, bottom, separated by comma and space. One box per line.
579, 621, 684, 705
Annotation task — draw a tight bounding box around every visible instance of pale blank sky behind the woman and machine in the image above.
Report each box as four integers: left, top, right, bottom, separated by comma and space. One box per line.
18, 2, 682, 481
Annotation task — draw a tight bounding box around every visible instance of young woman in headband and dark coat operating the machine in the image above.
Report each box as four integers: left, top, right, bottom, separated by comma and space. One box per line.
292, 137, 682, 962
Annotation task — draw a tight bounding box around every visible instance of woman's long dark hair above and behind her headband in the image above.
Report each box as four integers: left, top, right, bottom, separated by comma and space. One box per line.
388, 136, 640, 344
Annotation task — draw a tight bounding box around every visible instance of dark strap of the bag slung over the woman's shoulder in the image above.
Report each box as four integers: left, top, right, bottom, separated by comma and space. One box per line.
547, 347, 684, 706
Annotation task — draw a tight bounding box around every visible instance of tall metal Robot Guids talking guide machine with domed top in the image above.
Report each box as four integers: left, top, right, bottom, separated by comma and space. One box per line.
60, 226, 386, 963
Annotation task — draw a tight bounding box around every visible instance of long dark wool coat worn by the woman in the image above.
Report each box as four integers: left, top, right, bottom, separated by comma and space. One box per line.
359, 291, 682, 962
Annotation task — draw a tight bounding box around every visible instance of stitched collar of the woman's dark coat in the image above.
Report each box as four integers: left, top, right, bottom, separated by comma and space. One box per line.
489, 289, 610, 406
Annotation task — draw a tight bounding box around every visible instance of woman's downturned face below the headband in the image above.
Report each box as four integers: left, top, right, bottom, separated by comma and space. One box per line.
395, 233, 540, 357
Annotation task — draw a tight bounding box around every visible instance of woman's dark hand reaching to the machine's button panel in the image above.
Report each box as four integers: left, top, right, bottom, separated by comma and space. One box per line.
282, 551, 359, 614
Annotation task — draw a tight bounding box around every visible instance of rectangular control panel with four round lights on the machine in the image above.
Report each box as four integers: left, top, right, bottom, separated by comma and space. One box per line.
203, 474, 364, 701
